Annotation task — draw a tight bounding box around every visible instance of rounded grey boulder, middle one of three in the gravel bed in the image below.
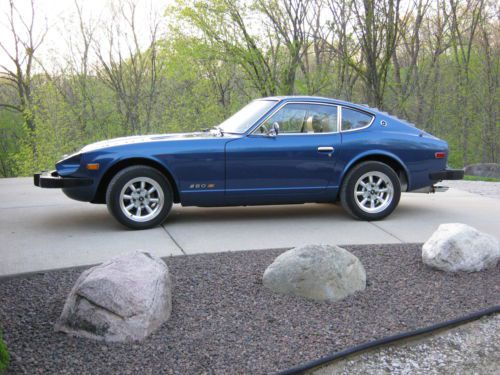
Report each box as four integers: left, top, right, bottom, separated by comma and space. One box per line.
263, 245, 366, 302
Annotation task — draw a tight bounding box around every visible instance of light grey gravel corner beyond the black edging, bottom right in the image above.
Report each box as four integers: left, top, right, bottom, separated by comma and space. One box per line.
311, 314, 500, 375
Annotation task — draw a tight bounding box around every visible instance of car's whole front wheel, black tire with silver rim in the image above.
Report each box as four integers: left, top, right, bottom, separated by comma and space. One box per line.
106, 165, 173, 229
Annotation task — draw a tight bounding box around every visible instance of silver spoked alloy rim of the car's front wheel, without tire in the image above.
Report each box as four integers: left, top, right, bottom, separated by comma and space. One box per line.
120, 177, 165, 223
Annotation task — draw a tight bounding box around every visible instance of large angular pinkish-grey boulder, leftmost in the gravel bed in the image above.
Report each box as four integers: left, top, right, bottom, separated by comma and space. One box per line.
55, 252, 172, 341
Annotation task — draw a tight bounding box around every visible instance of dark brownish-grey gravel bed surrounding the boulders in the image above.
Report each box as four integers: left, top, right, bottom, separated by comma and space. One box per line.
0, 244, 500, 374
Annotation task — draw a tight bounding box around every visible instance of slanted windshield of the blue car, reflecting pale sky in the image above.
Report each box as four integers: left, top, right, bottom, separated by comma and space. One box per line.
218, 100, 277, 134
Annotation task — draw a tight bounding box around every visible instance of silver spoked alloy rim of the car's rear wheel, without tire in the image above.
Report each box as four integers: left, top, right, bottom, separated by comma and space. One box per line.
354, 171, 394, 214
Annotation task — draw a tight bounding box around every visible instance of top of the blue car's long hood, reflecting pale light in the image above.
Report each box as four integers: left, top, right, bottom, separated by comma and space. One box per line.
80, 132, 226, 152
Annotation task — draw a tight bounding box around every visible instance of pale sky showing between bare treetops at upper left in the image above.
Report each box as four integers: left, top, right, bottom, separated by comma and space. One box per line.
0, 0, 174, 71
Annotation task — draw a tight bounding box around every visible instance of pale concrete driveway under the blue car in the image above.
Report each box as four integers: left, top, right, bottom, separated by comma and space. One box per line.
0, 178, 500, 275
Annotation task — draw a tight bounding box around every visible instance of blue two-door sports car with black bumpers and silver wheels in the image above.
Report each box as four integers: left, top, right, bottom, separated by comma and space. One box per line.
34, 96, 463, 229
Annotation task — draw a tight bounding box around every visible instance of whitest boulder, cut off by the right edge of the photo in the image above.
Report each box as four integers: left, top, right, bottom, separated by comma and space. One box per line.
422, 223, 500, 272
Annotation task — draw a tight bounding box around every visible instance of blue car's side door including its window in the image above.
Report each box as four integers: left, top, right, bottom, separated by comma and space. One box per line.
226, 102, 341, 204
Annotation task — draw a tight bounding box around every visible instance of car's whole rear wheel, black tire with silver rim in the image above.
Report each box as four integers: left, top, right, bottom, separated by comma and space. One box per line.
340, 161, 401, 221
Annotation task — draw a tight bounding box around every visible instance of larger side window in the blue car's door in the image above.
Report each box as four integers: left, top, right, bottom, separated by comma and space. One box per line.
259, 103, 338, 134
